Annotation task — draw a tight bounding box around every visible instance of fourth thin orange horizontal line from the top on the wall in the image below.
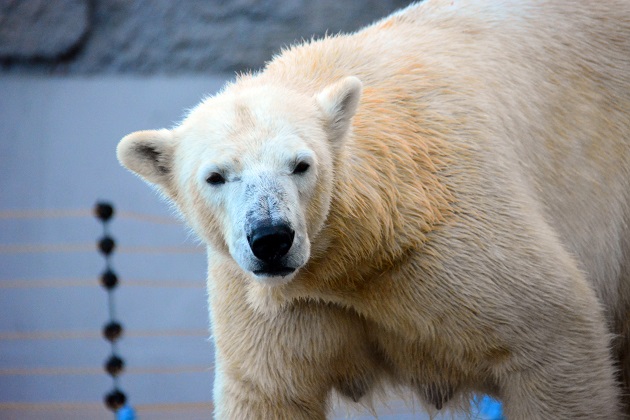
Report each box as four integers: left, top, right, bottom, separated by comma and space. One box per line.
0, 325, 210, 341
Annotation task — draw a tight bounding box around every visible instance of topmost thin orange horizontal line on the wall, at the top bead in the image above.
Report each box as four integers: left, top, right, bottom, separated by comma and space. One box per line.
0, 209, 182, 225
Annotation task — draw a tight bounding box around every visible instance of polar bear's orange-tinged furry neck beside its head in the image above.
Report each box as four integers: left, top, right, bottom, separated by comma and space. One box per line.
308, 100, 452, 291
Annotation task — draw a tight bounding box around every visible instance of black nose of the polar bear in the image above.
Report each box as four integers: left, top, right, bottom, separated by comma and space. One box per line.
247, 224, 295, 263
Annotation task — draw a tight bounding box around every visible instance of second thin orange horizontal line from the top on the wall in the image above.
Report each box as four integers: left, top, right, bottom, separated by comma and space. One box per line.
0, 243, 205, 254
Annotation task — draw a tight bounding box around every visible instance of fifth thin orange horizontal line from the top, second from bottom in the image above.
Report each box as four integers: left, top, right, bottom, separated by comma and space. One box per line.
0, 365, 214, 376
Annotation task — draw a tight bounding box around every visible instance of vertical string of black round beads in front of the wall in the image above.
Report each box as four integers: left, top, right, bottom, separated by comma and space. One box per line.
94, 203, 127, 412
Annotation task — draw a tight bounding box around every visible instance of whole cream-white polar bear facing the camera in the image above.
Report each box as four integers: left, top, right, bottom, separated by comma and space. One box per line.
118, 0, 630, 419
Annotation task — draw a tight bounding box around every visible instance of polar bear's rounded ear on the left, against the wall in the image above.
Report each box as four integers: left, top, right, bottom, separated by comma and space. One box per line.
116, 129, 175, 187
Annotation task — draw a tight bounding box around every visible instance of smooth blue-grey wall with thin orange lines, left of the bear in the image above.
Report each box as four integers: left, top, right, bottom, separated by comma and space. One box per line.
0, 77, 224, 419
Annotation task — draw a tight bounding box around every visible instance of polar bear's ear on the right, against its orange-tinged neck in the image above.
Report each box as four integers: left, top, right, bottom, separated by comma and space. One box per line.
316, 76, 363, 141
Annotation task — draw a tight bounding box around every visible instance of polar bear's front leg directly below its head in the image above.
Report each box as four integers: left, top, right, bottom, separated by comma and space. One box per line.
210, 274, 373, 420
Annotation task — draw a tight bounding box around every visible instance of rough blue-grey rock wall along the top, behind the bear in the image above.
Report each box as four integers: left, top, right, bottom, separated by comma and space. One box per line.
0, 0, 411, 75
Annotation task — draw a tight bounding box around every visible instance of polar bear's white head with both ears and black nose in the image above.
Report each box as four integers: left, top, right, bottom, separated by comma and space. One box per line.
118, 77, 361, 285
